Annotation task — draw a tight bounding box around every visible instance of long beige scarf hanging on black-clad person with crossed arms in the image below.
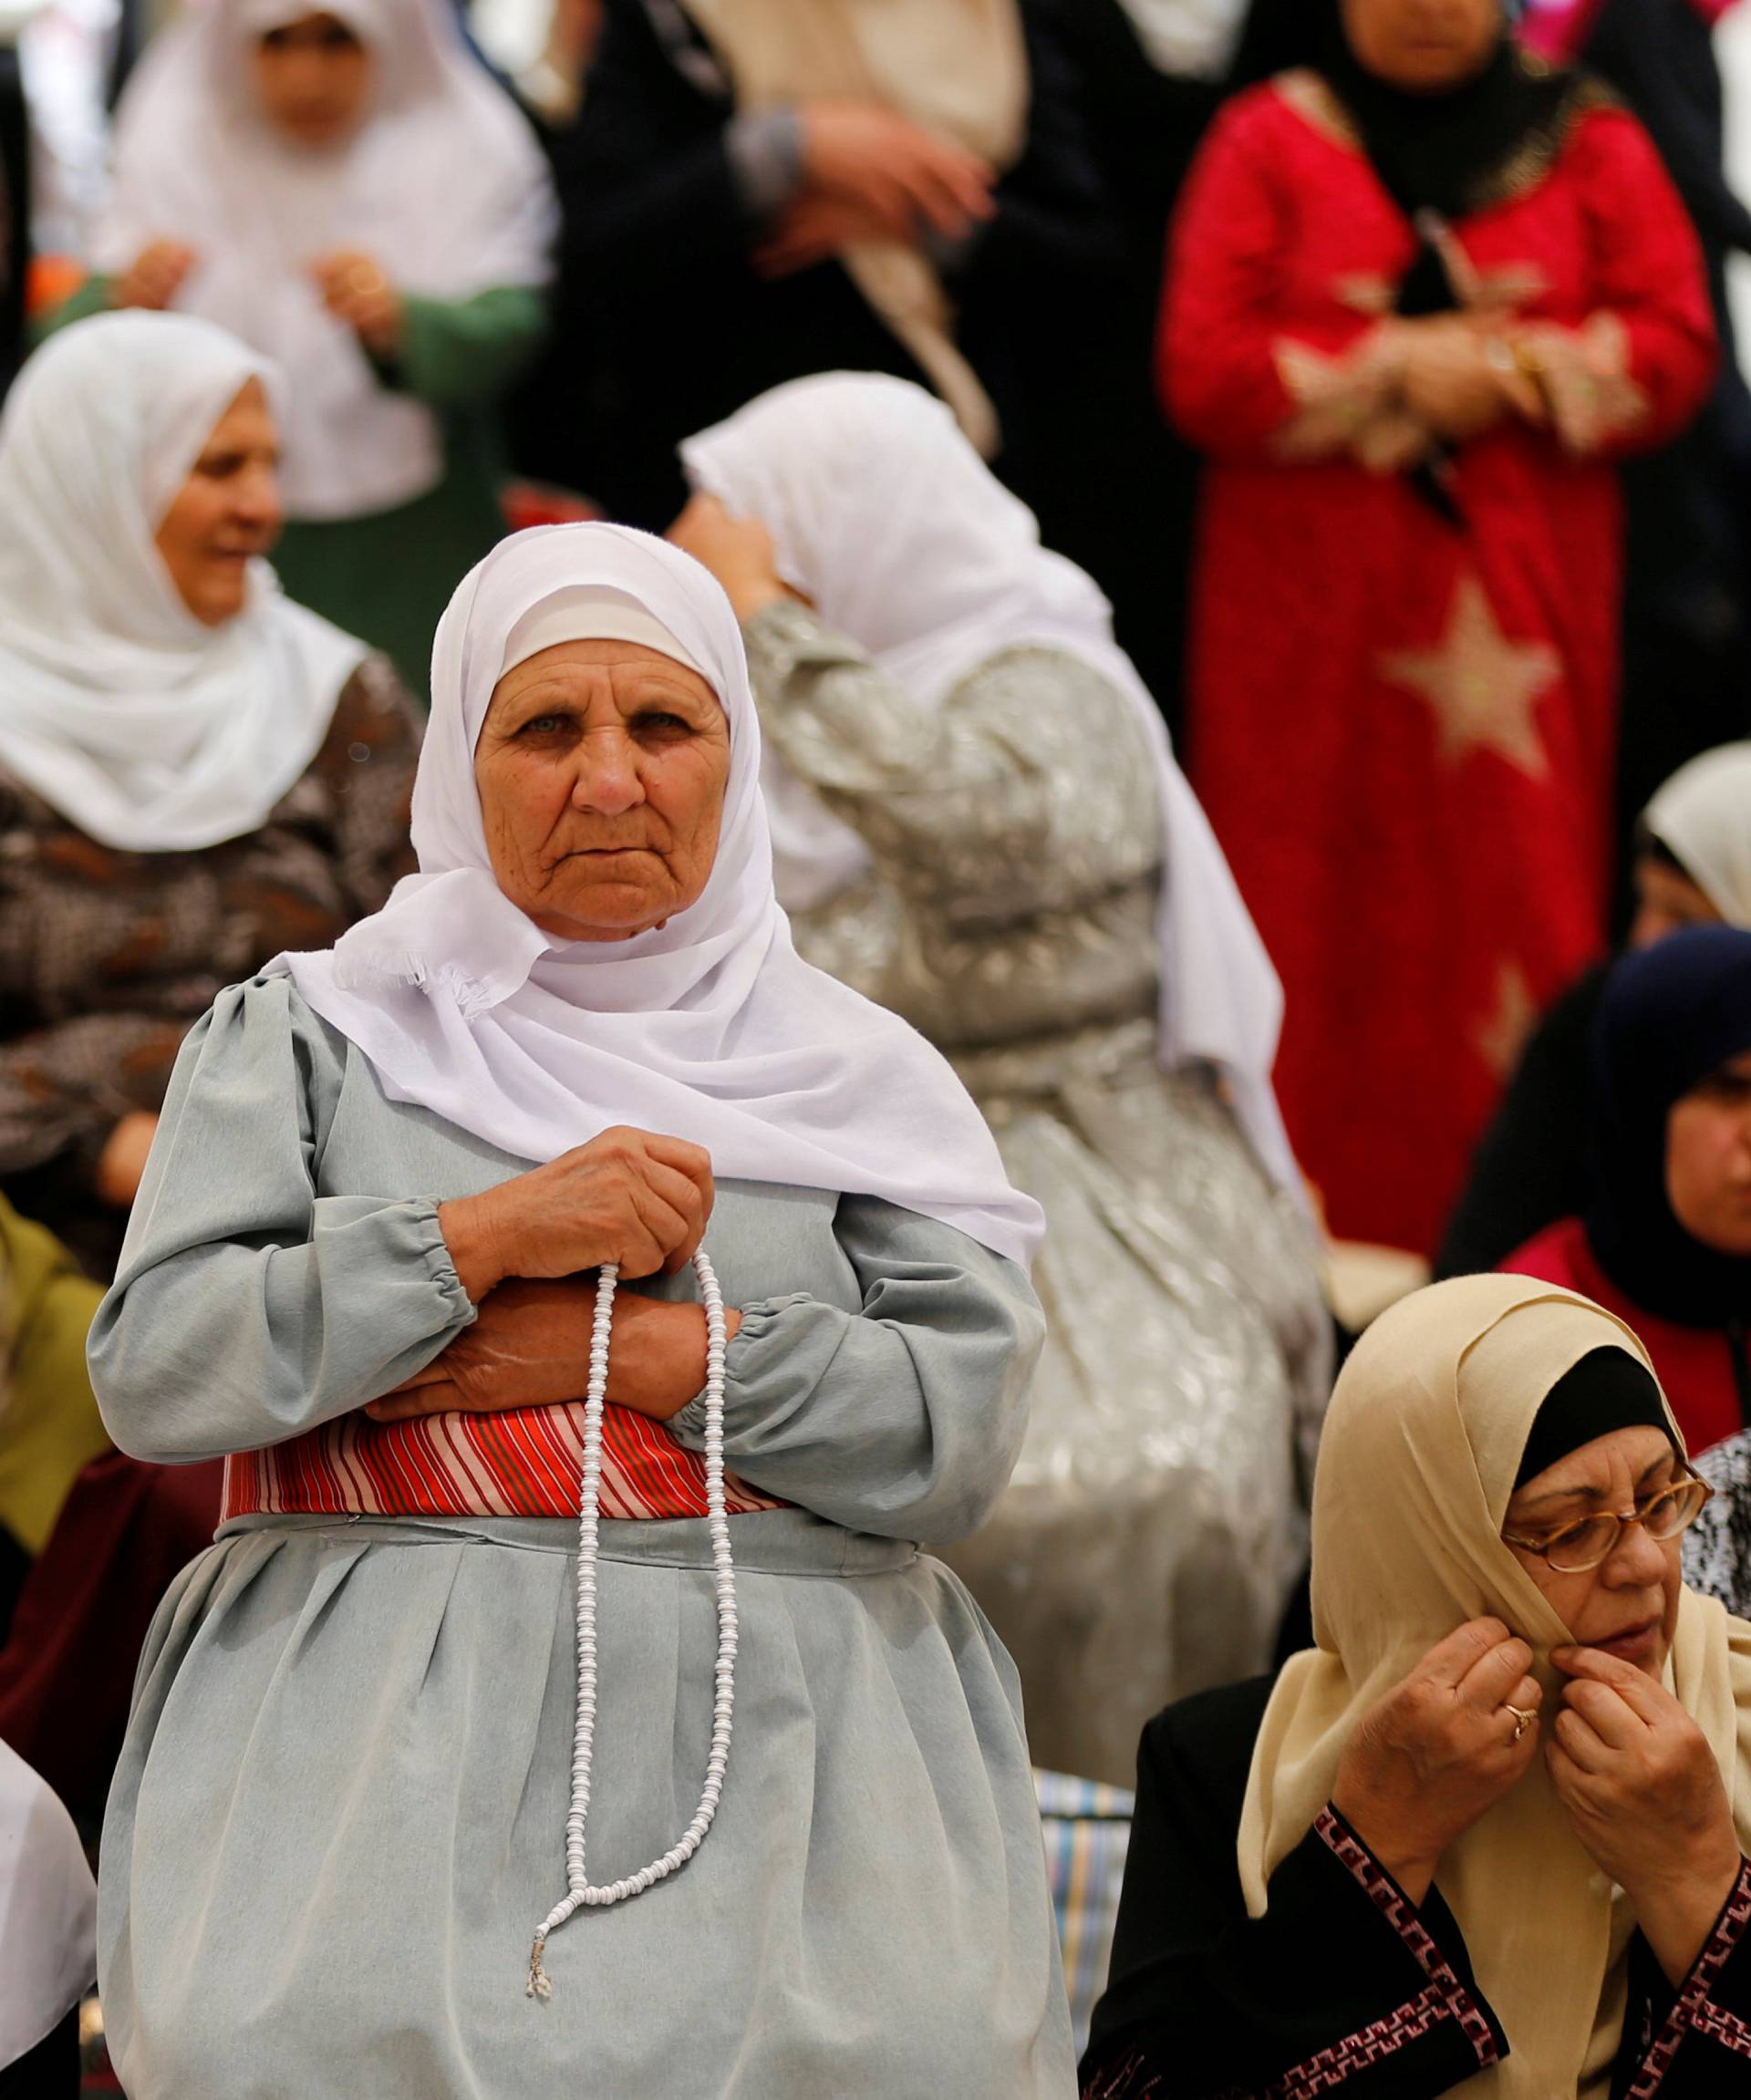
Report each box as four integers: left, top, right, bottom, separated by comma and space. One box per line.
687, 0, 1029, 460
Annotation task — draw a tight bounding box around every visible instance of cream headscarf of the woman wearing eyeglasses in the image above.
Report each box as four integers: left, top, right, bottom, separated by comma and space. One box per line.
1238, 1277, 1751, 2100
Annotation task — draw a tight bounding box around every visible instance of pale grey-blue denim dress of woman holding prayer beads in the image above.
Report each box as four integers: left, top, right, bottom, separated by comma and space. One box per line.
92, 978, 1075, 2100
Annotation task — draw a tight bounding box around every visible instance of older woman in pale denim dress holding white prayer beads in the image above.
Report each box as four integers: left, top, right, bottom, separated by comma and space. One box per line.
90, 525, 1072, 2100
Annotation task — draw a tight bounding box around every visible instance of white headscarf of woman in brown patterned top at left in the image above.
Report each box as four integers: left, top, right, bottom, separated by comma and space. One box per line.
0, 313, 366, 853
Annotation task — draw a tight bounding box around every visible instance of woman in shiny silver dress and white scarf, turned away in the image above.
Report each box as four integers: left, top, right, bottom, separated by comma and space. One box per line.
674, 374, 1331, 1781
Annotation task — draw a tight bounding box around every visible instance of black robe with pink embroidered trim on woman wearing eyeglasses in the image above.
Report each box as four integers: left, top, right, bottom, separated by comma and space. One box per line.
1082, 1678, 1751, 2100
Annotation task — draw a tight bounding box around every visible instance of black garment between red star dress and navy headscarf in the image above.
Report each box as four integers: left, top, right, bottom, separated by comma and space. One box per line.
1434, 962, 1611, 1281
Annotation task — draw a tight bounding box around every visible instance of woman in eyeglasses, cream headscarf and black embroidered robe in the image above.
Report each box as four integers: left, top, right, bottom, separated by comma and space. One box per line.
1082, 1277, 1751, 2100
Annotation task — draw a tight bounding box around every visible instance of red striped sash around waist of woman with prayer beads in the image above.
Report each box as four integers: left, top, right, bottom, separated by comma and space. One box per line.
223, 1401, 783, 1520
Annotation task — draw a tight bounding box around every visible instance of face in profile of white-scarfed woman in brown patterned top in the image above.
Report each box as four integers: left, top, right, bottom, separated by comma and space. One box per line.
155, 380, 281, 628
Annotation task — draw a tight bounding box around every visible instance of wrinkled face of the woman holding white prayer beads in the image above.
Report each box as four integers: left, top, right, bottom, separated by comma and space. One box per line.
474, 640, 730, 941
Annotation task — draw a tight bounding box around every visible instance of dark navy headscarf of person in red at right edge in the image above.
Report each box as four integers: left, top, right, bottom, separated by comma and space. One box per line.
1587, 926, 1751, 1327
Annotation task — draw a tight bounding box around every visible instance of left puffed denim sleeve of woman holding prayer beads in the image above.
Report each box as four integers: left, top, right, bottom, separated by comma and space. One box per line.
88, 978, 474, 1464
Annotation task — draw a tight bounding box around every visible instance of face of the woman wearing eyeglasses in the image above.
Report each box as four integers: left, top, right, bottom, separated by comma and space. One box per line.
1503, 1428, 1684, 1678
